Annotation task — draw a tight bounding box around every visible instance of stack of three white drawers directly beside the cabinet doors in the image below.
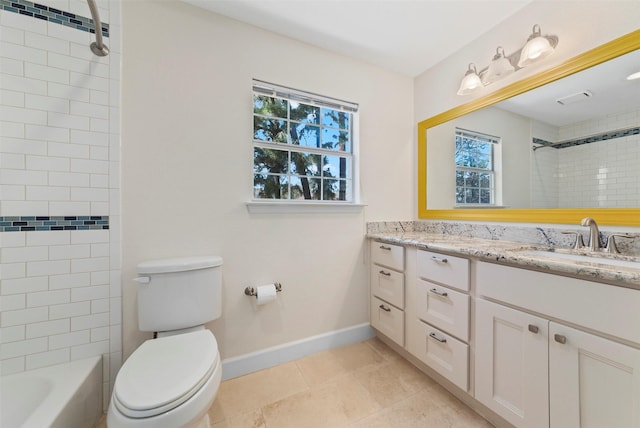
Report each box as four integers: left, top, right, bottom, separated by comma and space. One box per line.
411, 250, 470, 391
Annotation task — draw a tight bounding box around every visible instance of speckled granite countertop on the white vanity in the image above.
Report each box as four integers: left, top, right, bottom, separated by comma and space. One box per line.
367, 232, 640, 290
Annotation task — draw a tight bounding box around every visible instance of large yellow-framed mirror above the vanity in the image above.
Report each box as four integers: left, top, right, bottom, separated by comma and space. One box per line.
418, 30, 640, 226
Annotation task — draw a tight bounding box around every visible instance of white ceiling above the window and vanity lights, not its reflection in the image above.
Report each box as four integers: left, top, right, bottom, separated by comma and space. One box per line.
183, 0, 532, 77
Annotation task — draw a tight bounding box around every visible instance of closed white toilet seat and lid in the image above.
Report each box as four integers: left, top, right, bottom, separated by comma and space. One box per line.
113, 329, 219, 418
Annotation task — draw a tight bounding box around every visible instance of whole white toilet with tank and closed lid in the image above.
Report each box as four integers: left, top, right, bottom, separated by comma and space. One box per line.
107, 256, 222, 428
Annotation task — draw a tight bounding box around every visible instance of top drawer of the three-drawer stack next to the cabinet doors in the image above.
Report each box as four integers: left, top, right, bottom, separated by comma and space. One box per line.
418, 250, 469, 291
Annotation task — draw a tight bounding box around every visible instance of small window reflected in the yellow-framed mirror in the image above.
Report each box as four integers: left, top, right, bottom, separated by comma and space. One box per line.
456, 128, 500, 206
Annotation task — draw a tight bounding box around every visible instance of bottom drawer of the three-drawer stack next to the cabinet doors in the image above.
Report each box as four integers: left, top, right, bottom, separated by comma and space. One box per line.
414, 320, 469, 391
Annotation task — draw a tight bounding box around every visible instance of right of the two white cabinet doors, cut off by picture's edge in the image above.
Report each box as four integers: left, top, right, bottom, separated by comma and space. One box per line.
549, 322, 640, 428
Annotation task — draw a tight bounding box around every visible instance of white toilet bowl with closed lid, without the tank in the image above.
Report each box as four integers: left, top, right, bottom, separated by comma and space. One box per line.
107, 329, 222, 428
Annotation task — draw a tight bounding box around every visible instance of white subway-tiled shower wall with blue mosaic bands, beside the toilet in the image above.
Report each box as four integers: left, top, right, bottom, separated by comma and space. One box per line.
0, 0, 122, 404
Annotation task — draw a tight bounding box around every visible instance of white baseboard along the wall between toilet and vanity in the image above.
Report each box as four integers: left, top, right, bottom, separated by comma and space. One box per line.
222, 323, 375, 380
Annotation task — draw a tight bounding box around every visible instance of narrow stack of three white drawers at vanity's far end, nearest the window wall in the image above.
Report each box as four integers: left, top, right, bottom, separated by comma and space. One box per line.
369, 241, 405, 346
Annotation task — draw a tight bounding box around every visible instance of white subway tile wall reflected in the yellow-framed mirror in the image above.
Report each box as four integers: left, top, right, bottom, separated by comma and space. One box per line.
532, 109, 640, 208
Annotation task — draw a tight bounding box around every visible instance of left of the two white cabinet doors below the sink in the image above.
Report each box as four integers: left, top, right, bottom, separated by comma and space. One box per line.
475, 299, 549, 428
